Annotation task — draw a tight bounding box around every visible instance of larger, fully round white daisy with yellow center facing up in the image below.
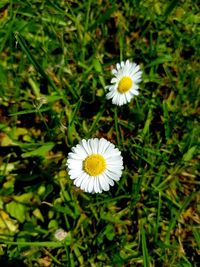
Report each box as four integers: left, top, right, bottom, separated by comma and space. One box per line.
67, 138, 123, 193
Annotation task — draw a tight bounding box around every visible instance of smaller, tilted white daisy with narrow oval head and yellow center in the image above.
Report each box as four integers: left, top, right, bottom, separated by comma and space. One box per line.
106, 60, 142, 106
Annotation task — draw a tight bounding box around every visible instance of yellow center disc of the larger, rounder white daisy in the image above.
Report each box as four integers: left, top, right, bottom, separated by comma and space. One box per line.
83, 154, 106, 176
